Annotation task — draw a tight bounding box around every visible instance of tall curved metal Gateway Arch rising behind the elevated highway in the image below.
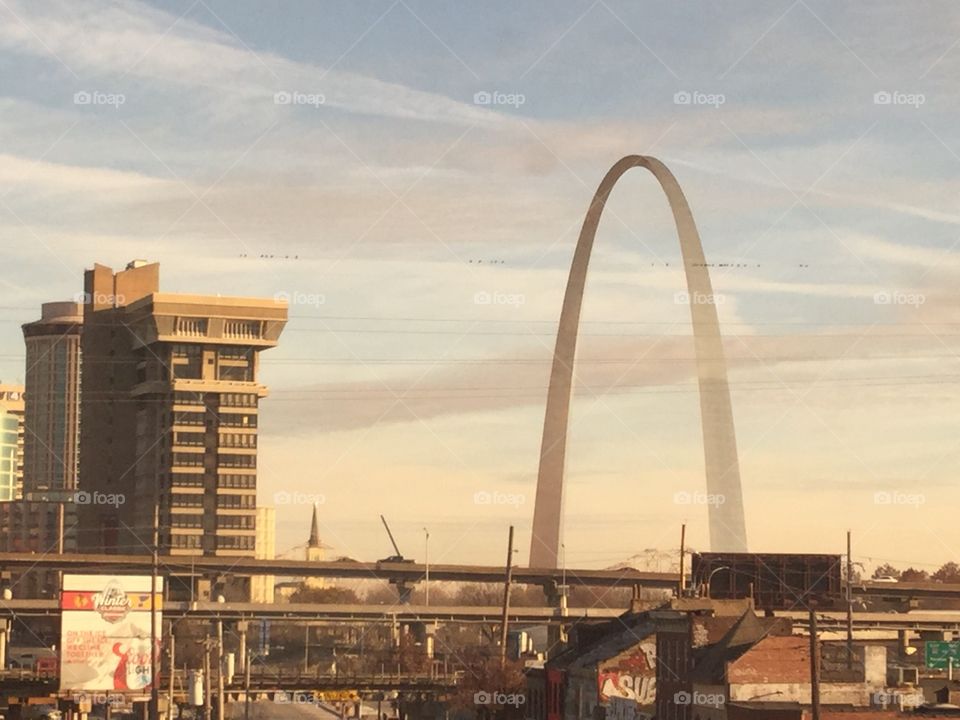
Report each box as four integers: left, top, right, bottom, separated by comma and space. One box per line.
530, 155, 747, 568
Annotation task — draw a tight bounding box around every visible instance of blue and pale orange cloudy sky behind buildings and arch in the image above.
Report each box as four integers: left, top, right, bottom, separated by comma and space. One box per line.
0, 0, 960, 569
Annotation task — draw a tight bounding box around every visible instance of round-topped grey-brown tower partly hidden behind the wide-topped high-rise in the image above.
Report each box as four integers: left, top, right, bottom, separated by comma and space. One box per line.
23, 302, 83, 495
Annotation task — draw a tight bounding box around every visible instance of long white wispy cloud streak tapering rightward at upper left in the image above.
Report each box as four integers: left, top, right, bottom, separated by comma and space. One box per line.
0, 0, 507, 127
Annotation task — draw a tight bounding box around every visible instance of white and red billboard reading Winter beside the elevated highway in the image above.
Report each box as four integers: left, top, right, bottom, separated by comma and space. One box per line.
60, 575, 163, 693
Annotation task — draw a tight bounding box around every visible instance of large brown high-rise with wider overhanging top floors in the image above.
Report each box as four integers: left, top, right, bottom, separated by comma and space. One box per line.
80, 261, 287, 557
